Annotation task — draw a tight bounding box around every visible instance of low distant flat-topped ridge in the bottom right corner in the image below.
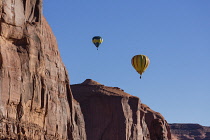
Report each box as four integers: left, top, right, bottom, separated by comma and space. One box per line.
170, 123, 210, 140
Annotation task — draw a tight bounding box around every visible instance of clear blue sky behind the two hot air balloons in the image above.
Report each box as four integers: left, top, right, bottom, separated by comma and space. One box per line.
43, 0, 210, 126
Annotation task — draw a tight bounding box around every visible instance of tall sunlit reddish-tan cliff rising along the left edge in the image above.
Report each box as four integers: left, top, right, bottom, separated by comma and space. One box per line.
0, 0, 86, 140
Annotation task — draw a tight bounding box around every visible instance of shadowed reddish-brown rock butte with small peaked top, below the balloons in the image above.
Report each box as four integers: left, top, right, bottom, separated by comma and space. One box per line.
71, 79, 171, 140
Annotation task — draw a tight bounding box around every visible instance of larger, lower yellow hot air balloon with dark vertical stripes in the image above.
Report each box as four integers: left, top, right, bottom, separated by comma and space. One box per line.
131, 54, 150, 79
